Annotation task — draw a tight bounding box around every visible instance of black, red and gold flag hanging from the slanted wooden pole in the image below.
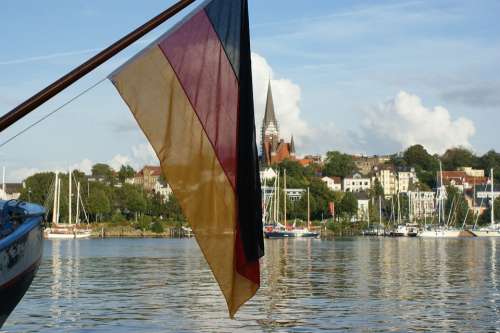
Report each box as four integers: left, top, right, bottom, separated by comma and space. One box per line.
110, 0, 264, 317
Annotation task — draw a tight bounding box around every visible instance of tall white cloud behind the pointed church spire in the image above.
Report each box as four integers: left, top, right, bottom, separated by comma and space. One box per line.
252, 53, 311, 146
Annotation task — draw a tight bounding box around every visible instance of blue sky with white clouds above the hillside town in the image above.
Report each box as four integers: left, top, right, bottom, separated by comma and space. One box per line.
0, 0, 500, 181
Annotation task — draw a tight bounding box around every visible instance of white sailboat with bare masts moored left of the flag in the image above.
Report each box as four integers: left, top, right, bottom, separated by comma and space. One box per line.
44, 170, 92, 239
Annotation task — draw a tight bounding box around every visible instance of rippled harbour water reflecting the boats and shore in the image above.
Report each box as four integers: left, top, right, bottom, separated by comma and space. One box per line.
2, 237, 500, 332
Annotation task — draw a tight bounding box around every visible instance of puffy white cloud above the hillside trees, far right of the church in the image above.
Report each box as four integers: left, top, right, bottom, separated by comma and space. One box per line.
362, 91, 475, 153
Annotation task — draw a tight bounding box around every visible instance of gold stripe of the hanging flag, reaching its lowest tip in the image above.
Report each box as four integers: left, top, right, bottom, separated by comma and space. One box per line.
111, 46, 258, 316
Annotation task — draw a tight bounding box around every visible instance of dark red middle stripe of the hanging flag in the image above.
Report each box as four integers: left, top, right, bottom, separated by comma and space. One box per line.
159, 10, 238, 189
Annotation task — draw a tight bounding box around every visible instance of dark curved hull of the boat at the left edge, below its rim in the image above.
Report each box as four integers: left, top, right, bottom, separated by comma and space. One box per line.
0, 205, 43, 328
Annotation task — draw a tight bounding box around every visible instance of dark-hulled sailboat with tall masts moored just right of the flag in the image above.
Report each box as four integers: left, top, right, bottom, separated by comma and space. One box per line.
264, 169, 319, 238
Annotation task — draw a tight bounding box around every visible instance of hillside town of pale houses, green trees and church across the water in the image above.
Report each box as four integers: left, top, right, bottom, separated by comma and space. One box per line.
0, 83, 500, 228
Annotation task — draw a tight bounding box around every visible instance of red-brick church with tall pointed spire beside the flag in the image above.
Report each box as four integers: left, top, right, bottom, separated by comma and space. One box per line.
261, 82, 295, 166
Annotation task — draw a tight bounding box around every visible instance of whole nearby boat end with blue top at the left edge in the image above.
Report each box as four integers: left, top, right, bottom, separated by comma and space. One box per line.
0, 200, 45, 327
